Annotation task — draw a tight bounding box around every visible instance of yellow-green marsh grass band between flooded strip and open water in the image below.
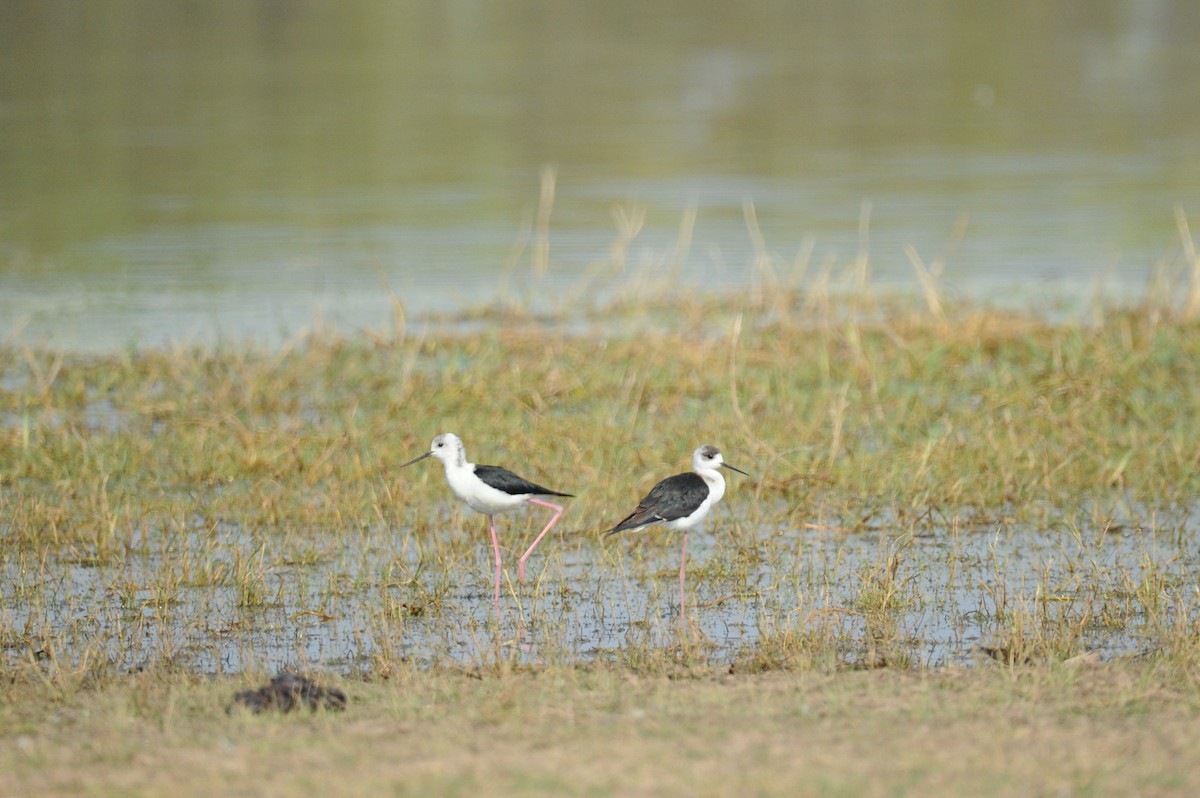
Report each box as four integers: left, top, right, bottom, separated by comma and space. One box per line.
9, 289, 1200, 537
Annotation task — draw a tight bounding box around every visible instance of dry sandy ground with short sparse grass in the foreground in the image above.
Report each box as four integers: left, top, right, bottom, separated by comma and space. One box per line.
0, 660, 1200, 797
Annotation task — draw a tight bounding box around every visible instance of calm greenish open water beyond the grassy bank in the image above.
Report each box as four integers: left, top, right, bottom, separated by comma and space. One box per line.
0, 0, 1200, 349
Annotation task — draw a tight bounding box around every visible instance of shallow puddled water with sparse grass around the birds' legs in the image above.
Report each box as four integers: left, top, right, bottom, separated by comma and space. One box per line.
0, 504, 1200, 672
